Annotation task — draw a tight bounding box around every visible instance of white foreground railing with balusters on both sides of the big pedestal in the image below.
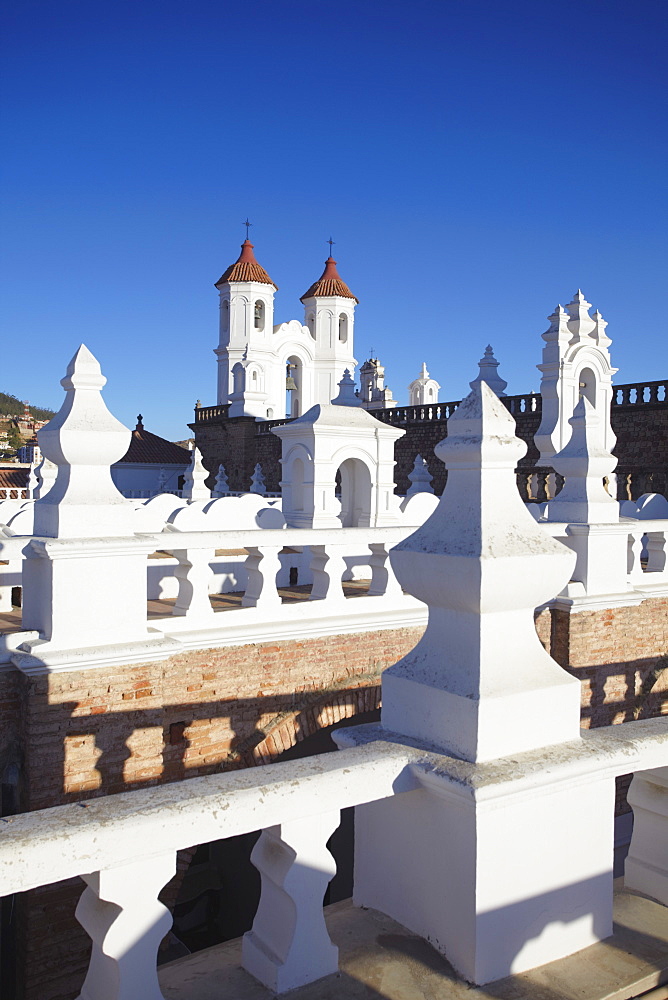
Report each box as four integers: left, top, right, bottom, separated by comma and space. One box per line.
0, 719, 668, 1000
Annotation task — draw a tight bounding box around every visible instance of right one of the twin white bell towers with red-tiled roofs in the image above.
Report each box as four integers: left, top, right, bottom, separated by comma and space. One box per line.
295, 256, 358, 415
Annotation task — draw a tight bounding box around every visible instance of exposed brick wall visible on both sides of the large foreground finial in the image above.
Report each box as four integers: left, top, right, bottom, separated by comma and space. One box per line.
7, 599, 668, 1000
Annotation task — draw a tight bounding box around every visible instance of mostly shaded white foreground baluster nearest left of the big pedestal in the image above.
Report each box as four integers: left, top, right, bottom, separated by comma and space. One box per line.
242, 810, 340, 993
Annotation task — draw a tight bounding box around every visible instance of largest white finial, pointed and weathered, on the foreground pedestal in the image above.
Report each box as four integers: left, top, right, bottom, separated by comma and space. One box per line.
382, 382, 580, 761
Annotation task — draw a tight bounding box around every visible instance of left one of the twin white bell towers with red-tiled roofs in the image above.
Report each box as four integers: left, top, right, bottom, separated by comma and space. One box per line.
215, 239, 278, 420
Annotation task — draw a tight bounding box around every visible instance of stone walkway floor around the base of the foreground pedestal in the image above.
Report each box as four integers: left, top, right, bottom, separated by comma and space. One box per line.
159, 879, 668, 1000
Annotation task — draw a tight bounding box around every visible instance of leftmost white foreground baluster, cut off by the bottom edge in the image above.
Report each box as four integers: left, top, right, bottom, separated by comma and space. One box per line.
76, 851, 176, 1000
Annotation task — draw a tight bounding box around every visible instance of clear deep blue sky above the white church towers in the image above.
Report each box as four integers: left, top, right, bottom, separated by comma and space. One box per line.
0, 0, 668, 439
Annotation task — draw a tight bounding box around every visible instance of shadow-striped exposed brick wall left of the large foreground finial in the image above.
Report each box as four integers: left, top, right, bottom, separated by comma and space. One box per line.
11, 628, 422, 1000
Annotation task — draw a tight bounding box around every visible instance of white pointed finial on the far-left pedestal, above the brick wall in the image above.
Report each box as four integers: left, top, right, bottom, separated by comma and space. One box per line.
34, 344, 133, 538
